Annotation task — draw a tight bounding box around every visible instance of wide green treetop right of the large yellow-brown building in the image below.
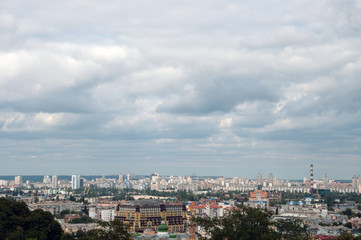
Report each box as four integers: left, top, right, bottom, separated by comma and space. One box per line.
194, 206, 309, 240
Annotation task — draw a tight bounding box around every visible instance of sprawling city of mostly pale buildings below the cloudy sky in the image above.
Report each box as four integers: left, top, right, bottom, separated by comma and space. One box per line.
0, 164, 361, 239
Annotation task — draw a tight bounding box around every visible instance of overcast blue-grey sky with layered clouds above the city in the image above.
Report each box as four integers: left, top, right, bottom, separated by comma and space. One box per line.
0, 0, 361, 179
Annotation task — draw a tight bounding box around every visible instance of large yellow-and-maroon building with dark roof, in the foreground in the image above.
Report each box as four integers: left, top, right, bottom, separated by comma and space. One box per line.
115, 201, 187, 233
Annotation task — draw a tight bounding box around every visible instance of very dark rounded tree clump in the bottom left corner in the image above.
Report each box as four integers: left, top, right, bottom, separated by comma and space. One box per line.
0, 198, 62, 240
